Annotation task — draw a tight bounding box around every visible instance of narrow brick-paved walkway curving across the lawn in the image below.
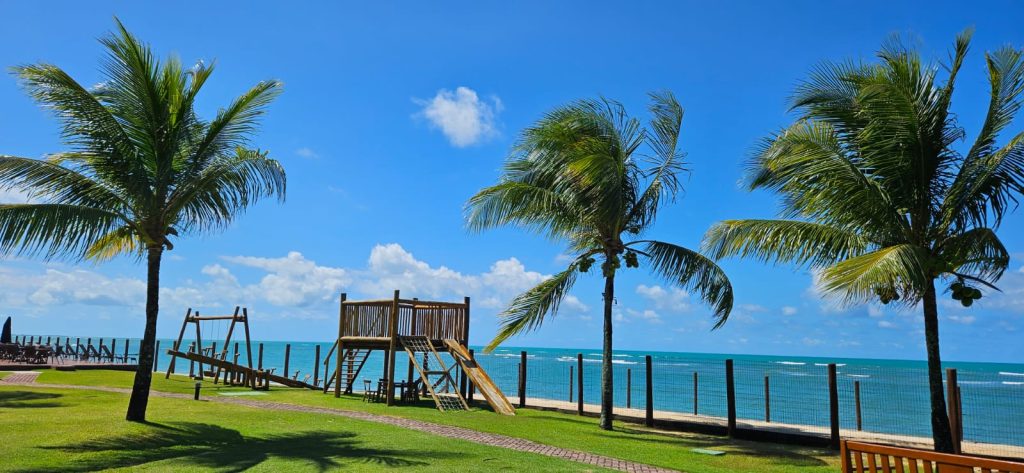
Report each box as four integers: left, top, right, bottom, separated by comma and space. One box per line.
3, 373, 678, 473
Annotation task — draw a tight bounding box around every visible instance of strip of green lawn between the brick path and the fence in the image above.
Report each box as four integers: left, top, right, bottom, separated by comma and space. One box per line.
38, 371, 839, 473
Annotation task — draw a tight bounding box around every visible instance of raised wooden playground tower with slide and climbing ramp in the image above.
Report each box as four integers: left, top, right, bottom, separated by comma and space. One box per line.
324, 291, 515, 416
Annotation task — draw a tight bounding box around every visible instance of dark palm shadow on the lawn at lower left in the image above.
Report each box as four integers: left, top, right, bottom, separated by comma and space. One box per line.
19, 423, 450, 472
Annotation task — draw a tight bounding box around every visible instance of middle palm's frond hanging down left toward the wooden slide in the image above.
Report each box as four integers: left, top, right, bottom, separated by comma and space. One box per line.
484, 262, 579, 353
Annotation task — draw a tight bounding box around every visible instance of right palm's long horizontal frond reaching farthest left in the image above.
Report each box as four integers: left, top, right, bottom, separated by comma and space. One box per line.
701, 220, 874, 266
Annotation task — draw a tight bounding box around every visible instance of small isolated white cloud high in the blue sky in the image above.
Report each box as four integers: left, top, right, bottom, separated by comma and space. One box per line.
416, 87, 502, 147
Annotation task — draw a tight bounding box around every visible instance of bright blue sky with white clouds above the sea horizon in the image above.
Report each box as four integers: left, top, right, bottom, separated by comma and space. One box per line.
0, 1, 1024, 361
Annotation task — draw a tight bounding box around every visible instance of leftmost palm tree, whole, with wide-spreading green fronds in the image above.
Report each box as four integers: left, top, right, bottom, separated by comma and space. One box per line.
0, 22, 286, 421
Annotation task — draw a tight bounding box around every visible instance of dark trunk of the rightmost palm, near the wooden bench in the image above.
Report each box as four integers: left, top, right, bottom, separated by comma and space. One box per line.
922, 280, 953, 454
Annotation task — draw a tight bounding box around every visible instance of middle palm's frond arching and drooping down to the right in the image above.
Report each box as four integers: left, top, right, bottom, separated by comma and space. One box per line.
630, 241, 733, 329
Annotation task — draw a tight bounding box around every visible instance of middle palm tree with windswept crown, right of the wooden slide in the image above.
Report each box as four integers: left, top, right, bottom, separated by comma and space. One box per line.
467, 92, 732, 430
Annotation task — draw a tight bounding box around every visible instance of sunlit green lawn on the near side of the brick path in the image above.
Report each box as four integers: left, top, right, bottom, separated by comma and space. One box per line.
0, 386, 605, 472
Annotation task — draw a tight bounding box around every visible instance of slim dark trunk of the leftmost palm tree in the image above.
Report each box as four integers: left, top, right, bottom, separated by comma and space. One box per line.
127, 247, 164, 422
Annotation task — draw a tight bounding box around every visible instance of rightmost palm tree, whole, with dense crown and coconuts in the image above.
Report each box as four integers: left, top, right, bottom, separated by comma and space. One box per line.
705, 32, 1024, 452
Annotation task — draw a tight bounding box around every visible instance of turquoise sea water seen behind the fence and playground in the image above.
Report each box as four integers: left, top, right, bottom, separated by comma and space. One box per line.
28, 331, 1024, 446
